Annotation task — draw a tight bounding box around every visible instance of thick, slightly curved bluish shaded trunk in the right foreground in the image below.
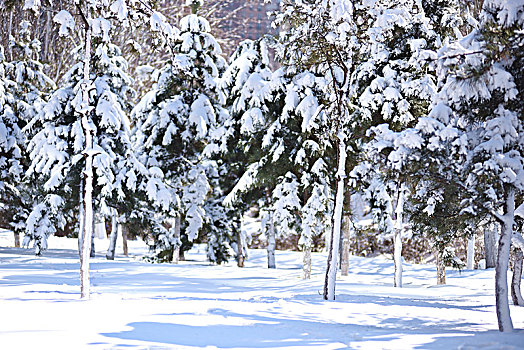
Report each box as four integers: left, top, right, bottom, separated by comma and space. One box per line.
495, 184, 515, 332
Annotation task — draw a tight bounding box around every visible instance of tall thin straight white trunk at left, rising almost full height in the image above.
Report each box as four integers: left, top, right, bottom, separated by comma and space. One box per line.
80, 17, 93, 299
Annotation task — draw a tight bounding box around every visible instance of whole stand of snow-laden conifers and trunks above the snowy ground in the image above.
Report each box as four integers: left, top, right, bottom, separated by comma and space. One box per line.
0, 0, 524, 331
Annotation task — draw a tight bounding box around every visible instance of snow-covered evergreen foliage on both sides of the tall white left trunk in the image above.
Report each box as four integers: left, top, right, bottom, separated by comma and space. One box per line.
26, 26, 139, 252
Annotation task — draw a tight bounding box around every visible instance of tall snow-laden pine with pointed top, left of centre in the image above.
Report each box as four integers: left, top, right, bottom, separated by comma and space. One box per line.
132, 5, 227, 262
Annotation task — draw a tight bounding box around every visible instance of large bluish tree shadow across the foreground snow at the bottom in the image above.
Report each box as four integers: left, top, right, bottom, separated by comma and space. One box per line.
101, 308, 512, 350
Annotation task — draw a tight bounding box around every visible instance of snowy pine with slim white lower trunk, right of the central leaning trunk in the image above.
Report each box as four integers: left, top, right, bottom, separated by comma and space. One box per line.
353, 0, 461, 287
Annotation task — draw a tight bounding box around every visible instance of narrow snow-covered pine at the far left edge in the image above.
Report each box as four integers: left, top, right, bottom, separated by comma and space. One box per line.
2, 20, 55, 247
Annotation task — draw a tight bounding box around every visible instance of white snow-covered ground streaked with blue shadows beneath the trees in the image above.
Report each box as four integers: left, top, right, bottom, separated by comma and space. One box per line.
0, 233, 524, 350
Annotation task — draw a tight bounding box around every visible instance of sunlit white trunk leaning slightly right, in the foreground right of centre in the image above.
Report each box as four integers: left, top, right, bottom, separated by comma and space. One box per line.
324, 134, 346, 300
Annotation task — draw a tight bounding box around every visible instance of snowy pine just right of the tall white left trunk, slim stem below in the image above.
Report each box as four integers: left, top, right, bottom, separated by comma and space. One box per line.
92, 38, 147, 259
